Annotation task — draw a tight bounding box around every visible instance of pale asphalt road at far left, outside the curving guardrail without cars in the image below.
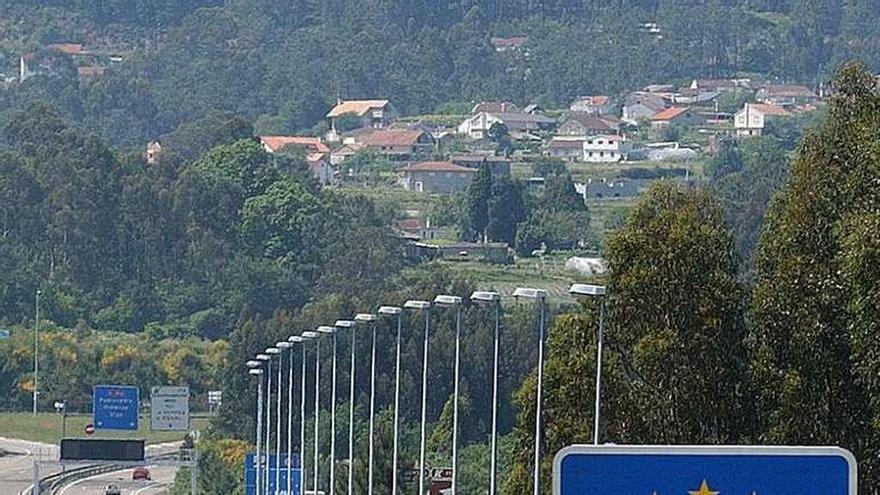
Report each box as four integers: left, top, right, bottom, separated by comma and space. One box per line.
0, 437, 60, 495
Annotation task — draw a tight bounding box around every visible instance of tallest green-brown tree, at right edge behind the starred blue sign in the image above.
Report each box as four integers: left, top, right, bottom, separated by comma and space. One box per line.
750, 64, 880, 493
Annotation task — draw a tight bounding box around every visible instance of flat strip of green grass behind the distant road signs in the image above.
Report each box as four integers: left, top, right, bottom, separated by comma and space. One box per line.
0, 413, 208, 444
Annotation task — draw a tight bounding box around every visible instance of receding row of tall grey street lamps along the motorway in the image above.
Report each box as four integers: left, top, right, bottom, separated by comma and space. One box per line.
246, 284, 606, 495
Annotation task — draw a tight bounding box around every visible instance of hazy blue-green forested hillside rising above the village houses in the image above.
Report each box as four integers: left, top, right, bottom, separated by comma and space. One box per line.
0, 0, 880, 147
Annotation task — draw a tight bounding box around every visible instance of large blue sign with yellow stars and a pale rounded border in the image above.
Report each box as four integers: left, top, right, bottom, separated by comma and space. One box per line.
553, 446, 857, 495
